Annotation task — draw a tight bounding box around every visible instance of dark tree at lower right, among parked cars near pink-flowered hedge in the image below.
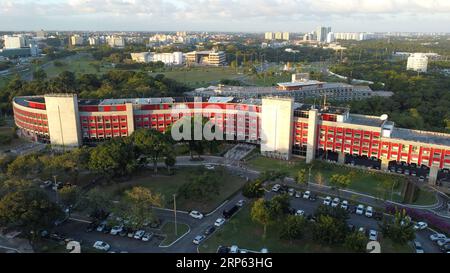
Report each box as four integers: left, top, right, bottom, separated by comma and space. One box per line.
379, 207, 416, 244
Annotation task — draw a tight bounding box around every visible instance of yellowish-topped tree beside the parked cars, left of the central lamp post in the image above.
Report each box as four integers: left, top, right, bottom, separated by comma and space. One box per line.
120, 187, 164, 228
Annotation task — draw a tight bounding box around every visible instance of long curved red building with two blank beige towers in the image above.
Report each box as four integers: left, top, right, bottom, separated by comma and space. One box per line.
13, 94, 450, 181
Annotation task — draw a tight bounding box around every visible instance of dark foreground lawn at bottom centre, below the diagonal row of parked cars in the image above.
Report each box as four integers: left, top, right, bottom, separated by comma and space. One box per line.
199, 204, 412, 253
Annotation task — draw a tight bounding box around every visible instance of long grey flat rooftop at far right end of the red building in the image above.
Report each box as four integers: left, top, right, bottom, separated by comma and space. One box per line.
391, 128, 450, 146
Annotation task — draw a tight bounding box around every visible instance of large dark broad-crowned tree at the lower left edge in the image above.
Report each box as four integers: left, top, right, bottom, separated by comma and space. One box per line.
0, 189, 63, 242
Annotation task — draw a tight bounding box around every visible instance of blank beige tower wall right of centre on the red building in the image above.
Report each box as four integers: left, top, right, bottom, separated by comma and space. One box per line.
261, 98, 294, 160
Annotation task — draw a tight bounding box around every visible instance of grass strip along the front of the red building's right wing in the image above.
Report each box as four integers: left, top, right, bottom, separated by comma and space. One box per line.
248, 156, 436, 205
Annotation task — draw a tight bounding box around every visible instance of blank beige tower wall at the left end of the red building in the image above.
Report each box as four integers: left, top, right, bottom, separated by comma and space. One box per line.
45, 94, 82, 148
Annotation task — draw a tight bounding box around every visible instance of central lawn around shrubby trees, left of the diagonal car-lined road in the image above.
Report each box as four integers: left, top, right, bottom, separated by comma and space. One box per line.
96, 168, 245, 212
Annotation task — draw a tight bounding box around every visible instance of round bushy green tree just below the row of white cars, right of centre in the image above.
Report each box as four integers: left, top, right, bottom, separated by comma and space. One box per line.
312, 215, 347, 244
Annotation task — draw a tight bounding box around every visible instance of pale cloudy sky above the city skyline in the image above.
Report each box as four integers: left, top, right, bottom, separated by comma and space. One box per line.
0, 0, 450, 32
